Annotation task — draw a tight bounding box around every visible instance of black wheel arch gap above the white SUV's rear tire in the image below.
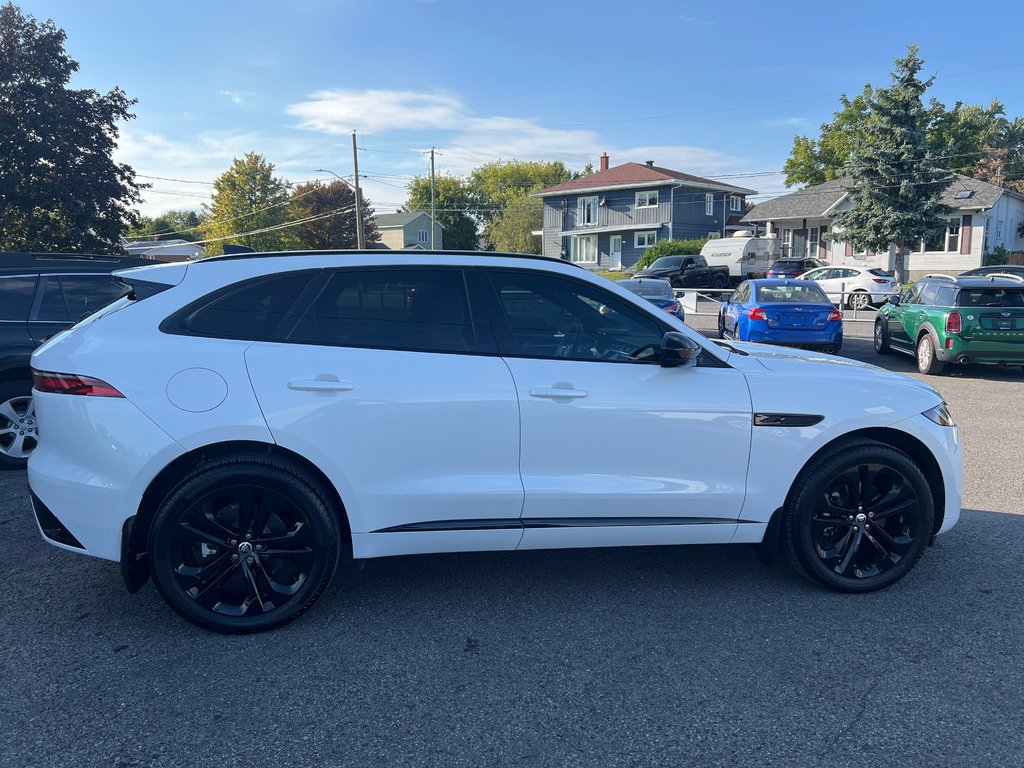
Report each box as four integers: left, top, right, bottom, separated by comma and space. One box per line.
121, 440, 352, 591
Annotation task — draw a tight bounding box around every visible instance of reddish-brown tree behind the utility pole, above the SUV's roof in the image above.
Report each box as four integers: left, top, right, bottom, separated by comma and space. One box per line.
285, 181, 380, 251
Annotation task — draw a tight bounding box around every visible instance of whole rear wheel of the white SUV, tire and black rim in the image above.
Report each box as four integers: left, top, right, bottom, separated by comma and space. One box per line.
150, 455, 341, 634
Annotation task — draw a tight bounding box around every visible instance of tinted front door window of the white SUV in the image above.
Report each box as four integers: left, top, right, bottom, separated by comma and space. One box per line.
490, 271, 664, 362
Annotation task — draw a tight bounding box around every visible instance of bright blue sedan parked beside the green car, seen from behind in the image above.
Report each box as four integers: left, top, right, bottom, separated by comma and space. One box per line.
718, 279, 843, 354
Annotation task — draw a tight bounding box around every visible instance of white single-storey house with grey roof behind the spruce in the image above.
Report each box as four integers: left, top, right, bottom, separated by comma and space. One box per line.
743, 174, 1024, 280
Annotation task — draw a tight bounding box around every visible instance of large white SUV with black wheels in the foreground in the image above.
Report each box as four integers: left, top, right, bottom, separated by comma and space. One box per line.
29, 251, 963, 632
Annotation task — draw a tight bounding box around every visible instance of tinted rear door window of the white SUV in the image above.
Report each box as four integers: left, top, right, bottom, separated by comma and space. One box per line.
288, 269, 476, 352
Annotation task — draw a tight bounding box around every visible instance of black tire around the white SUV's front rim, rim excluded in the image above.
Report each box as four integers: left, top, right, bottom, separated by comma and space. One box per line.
785, 443, 935, 592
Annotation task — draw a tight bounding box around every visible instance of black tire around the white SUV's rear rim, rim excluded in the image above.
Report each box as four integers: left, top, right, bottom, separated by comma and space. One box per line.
150, 458, 340, 633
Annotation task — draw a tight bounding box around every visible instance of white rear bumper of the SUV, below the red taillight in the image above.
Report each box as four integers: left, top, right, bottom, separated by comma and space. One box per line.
29, 391, 184, 560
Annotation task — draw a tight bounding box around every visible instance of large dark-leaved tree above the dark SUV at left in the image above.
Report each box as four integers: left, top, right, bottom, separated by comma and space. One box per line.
0, 2, 141, 252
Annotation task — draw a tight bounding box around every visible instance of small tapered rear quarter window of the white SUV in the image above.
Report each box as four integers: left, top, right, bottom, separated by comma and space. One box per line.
173, 272, 315, 341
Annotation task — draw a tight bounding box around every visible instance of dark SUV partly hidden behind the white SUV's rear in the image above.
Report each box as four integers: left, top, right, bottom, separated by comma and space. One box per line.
0, 253, 154, 469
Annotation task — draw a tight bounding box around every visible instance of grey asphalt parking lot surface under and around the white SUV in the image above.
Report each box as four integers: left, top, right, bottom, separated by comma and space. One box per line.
0, 322, 1024, 768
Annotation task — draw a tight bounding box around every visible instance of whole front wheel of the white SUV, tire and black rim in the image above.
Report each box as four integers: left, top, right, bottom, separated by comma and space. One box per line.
782, 440, 935, 592
